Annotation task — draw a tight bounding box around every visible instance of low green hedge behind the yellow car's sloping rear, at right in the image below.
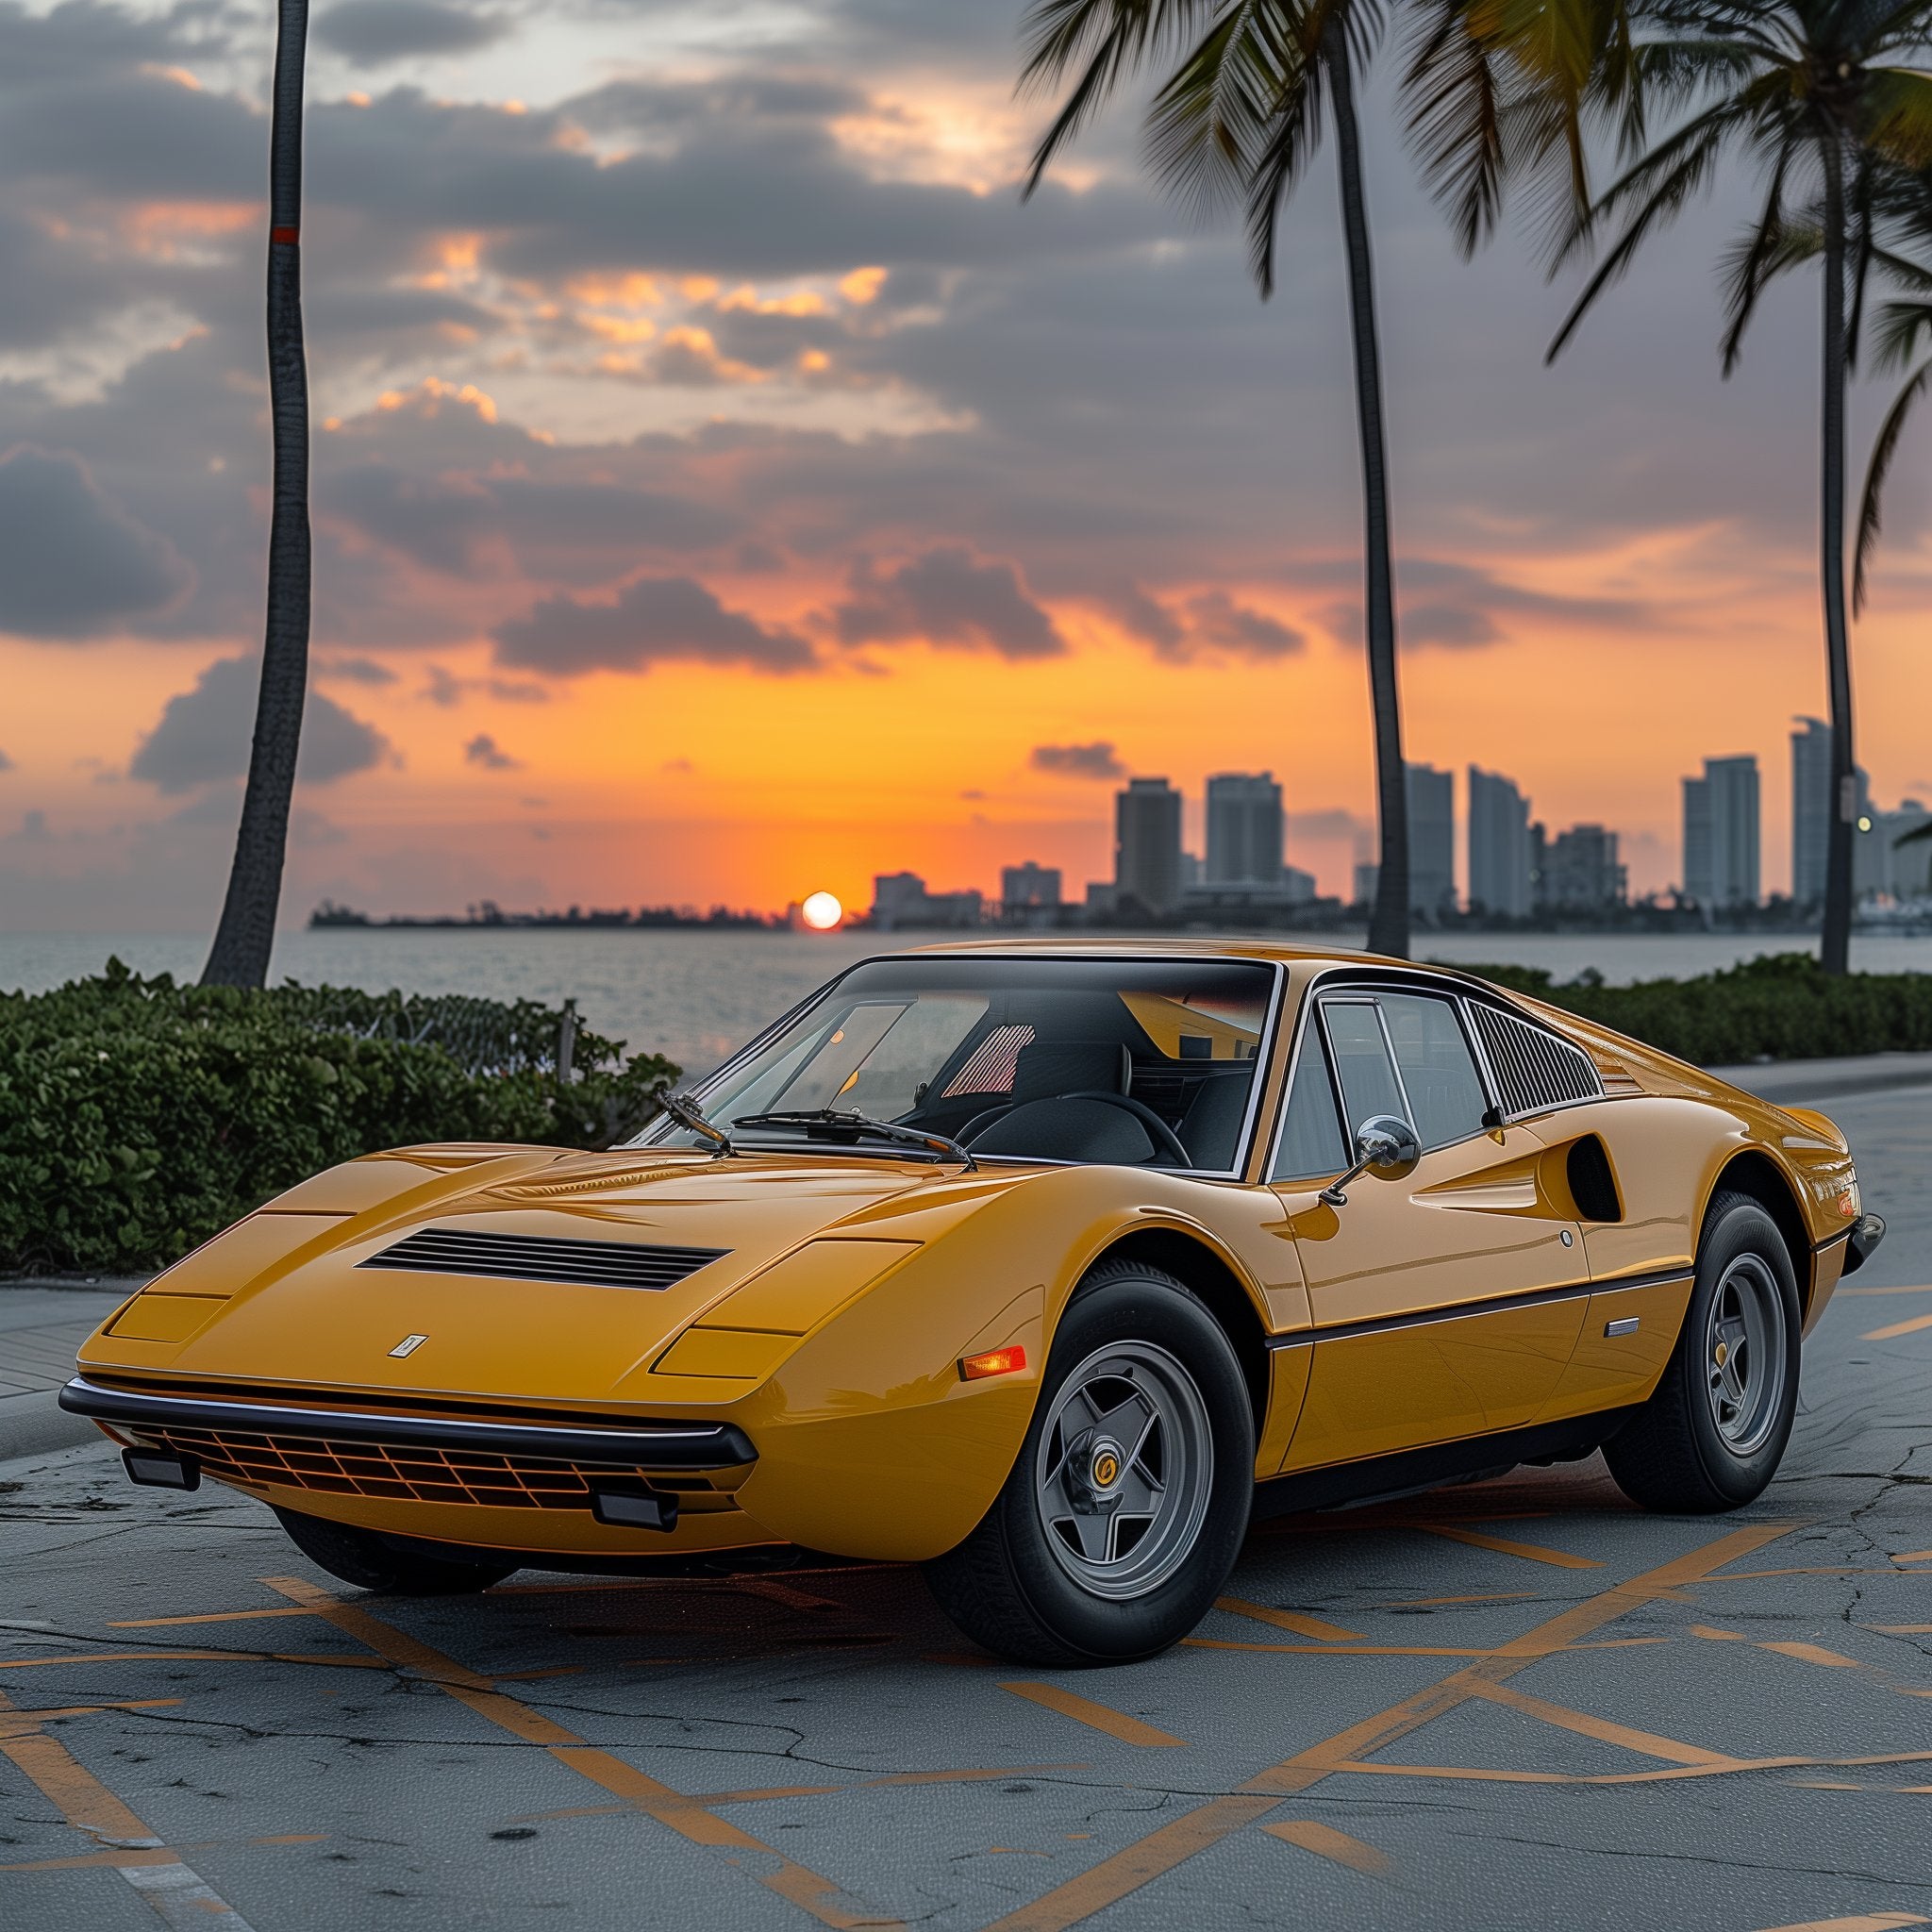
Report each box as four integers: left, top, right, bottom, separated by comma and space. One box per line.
1460, 953, 1932, 1066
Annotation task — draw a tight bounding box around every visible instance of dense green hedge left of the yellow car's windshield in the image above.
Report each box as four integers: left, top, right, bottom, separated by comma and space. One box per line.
0, 960, 678, 1274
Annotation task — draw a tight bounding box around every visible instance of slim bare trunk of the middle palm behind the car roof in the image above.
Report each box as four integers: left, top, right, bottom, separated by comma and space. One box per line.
1322, 26, 1408, 958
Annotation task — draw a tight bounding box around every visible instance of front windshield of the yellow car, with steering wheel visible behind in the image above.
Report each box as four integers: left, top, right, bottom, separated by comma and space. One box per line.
640, 957, 1275, 1173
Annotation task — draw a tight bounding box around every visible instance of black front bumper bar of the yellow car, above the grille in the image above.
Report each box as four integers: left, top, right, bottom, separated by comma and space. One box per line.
59, 1375, 758, 1468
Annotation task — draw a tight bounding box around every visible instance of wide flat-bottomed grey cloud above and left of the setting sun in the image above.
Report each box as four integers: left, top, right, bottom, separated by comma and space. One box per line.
491, 577, 817, 678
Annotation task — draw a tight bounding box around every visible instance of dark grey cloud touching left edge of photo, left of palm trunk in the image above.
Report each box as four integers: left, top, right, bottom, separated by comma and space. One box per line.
0, 442, 193, 638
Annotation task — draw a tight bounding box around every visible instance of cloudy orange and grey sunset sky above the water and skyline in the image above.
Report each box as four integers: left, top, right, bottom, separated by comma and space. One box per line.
0, 0, 1932, 931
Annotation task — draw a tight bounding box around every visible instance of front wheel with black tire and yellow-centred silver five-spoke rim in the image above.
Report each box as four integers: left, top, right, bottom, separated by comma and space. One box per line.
925, 1261, 1254, 1665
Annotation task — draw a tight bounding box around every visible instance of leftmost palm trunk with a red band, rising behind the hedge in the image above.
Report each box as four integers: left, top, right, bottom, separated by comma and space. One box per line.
201, 0, 309, 985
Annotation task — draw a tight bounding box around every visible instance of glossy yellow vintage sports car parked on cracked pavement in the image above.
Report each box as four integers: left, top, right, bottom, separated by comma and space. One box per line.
62, 939, 1884, 1663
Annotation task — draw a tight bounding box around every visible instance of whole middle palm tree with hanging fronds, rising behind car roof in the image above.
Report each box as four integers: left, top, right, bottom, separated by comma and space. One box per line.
1020, 0, 1628, 957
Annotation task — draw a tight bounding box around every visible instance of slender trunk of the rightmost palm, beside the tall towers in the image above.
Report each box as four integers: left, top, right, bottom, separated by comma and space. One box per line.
1818, 131, 1858, 974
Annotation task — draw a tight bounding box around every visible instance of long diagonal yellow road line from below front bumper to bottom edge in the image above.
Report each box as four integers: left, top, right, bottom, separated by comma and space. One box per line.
263, 1576, 898, 1932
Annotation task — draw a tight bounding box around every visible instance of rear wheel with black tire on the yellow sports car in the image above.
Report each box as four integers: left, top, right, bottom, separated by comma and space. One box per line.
1604, 1192, 1801, 1517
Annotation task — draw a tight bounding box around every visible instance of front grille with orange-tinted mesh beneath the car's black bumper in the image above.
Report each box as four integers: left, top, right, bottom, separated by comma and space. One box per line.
142, 1425, 703, 1508
